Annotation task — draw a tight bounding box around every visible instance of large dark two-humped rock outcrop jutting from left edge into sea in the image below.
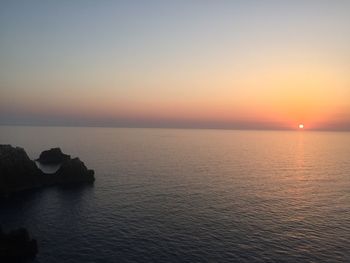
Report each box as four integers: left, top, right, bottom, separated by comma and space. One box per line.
0, 145, 95, 196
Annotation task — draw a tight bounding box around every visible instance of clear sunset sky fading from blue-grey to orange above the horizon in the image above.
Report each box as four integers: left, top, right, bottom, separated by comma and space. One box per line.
0, 0, 350, 130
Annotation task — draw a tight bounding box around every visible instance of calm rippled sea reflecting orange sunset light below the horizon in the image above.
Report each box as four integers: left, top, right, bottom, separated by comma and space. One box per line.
0, 126, 350, 263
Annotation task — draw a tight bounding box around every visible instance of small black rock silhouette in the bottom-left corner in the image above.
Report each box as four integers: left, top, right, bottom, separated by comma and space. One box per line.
0, 227, 38, 263
